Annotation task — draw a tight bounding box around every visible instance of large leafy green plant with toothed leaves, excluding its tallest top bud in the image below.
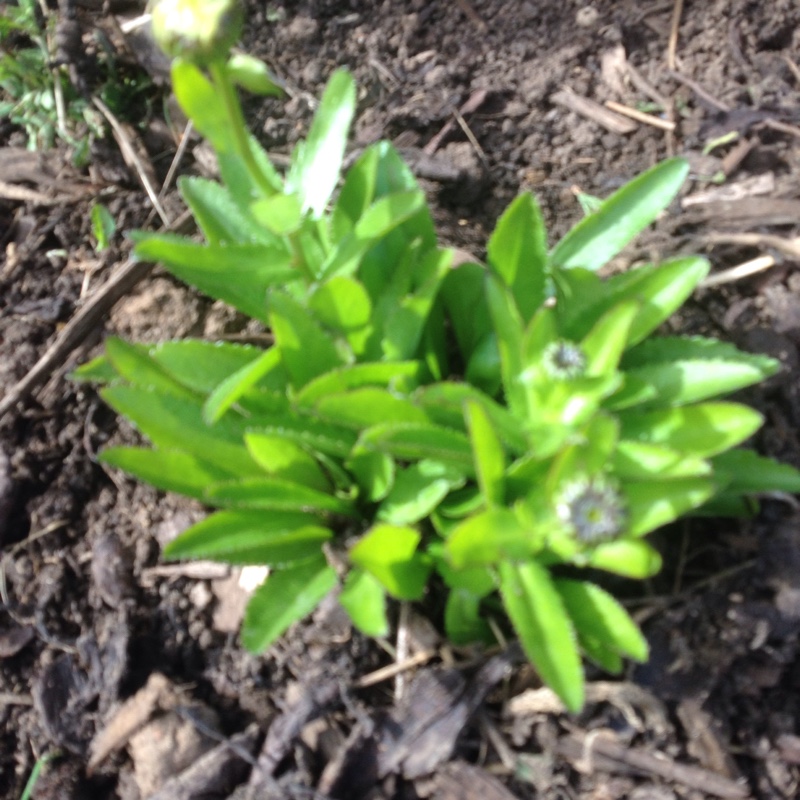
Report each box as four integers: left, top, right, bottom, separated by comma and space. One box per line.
78, 1, 800, 709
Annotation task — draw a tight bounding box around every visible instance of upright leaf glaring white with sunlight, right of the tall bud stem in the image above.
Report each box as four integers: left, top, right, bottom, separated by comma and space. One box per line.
286, 69, 356, 217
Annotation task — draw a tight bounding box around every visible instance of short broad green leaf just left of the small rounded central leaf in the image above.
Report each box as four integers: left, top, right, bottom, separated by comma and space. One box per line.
269, 292, 343, 389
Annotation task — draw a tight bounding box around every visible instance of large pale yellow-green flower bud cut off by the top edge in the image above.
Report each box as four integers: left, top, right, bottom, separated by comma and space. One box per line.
151, 0, 244, 64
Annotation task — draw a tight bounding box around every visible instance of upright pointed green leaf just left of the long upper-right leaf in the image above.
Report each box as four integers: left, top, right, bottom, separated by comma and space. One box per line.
486, 192, 547, 321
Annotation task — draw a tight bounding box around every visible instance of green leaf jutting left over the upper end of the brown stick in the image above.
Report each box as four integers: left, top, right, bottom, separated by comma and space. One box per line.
134, 233, 299, 322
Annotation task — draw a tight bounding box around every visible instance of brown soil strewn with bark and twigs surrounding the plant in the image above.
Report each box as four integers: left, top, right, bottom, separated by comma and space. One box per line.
0, 0, 800, 800
